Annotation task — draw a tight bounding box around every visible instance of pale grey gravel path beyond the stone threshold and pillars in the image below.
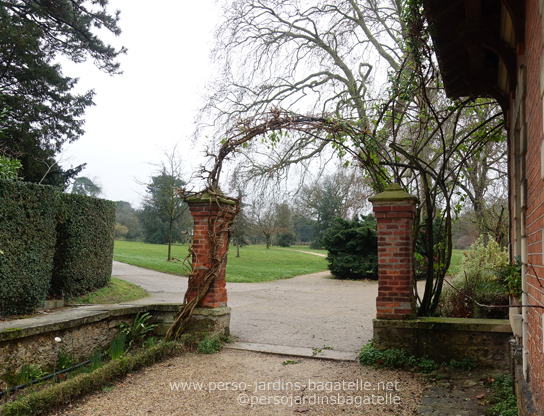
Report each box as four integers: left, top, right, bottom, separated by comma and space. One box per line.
112, 260, 378, 357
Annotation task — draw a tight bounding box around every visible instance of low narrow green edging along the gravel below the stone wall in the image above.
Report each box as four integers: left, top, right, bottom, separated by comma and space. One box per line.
0, 341, 185, 416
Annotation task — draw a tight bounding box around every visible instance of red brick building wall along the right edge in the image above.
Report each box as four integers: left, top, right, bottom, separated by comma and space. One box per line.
525, 0, 544, 411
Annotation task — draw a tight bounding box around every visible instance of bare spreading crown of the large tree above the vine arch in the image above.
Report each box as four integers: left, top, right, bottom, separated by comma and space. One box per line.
206, 0, 406, 132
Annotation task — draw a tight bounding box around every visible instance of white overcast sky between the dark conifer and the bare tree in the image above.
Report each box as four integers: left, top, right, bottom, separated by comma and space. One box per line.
61, 0, 219, 206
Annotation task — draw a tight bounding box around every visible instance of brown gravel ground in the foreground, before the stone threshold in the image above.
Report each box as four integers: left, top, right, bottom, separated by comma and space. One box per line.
55, 350, 422, 416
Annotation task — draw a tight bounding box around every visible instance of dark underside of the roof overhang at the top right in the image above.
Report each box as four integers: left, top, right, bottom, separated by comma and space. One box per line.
424, 0, 525, 111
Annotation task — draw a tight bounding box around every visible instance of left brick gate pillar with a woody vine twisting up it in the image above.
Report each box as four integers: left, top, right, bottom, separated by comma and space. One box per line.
187, 193, 235, 308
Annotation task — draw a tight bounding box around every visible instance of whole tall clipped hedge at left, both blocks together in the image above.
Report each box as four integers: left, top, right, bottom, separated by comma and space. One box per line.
0, 180, 115, 315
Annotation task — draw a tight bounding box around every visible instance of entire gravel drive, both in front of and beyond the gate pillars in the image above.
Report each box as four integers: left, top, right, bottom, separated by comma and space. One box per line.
56, 262, 423, 416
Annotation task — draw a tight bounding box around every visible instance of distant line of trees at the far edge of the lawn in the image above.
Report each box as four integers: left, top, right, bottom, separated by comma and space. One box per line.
111, 165, 508, 257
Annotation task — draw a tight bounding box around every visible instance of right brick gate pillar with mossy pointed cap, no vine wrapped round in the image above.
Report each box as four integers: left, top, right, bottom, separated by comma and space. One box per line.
368, 183, 418, 319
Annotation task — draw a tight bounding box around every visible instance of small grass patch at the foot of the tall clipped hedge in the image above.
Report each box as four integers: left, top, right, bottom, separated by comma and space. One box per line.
66, 277, 148, 305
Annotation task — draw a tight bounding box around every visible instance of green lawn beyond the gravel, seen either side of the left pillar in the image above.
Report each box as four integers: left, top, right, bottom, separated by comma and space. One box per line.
113, 241, 327, 282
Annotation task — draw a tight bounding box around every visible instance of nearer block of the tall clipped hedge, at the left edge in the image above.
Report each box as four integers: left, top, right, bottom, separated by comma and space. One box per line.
0, 180, 58, 315
